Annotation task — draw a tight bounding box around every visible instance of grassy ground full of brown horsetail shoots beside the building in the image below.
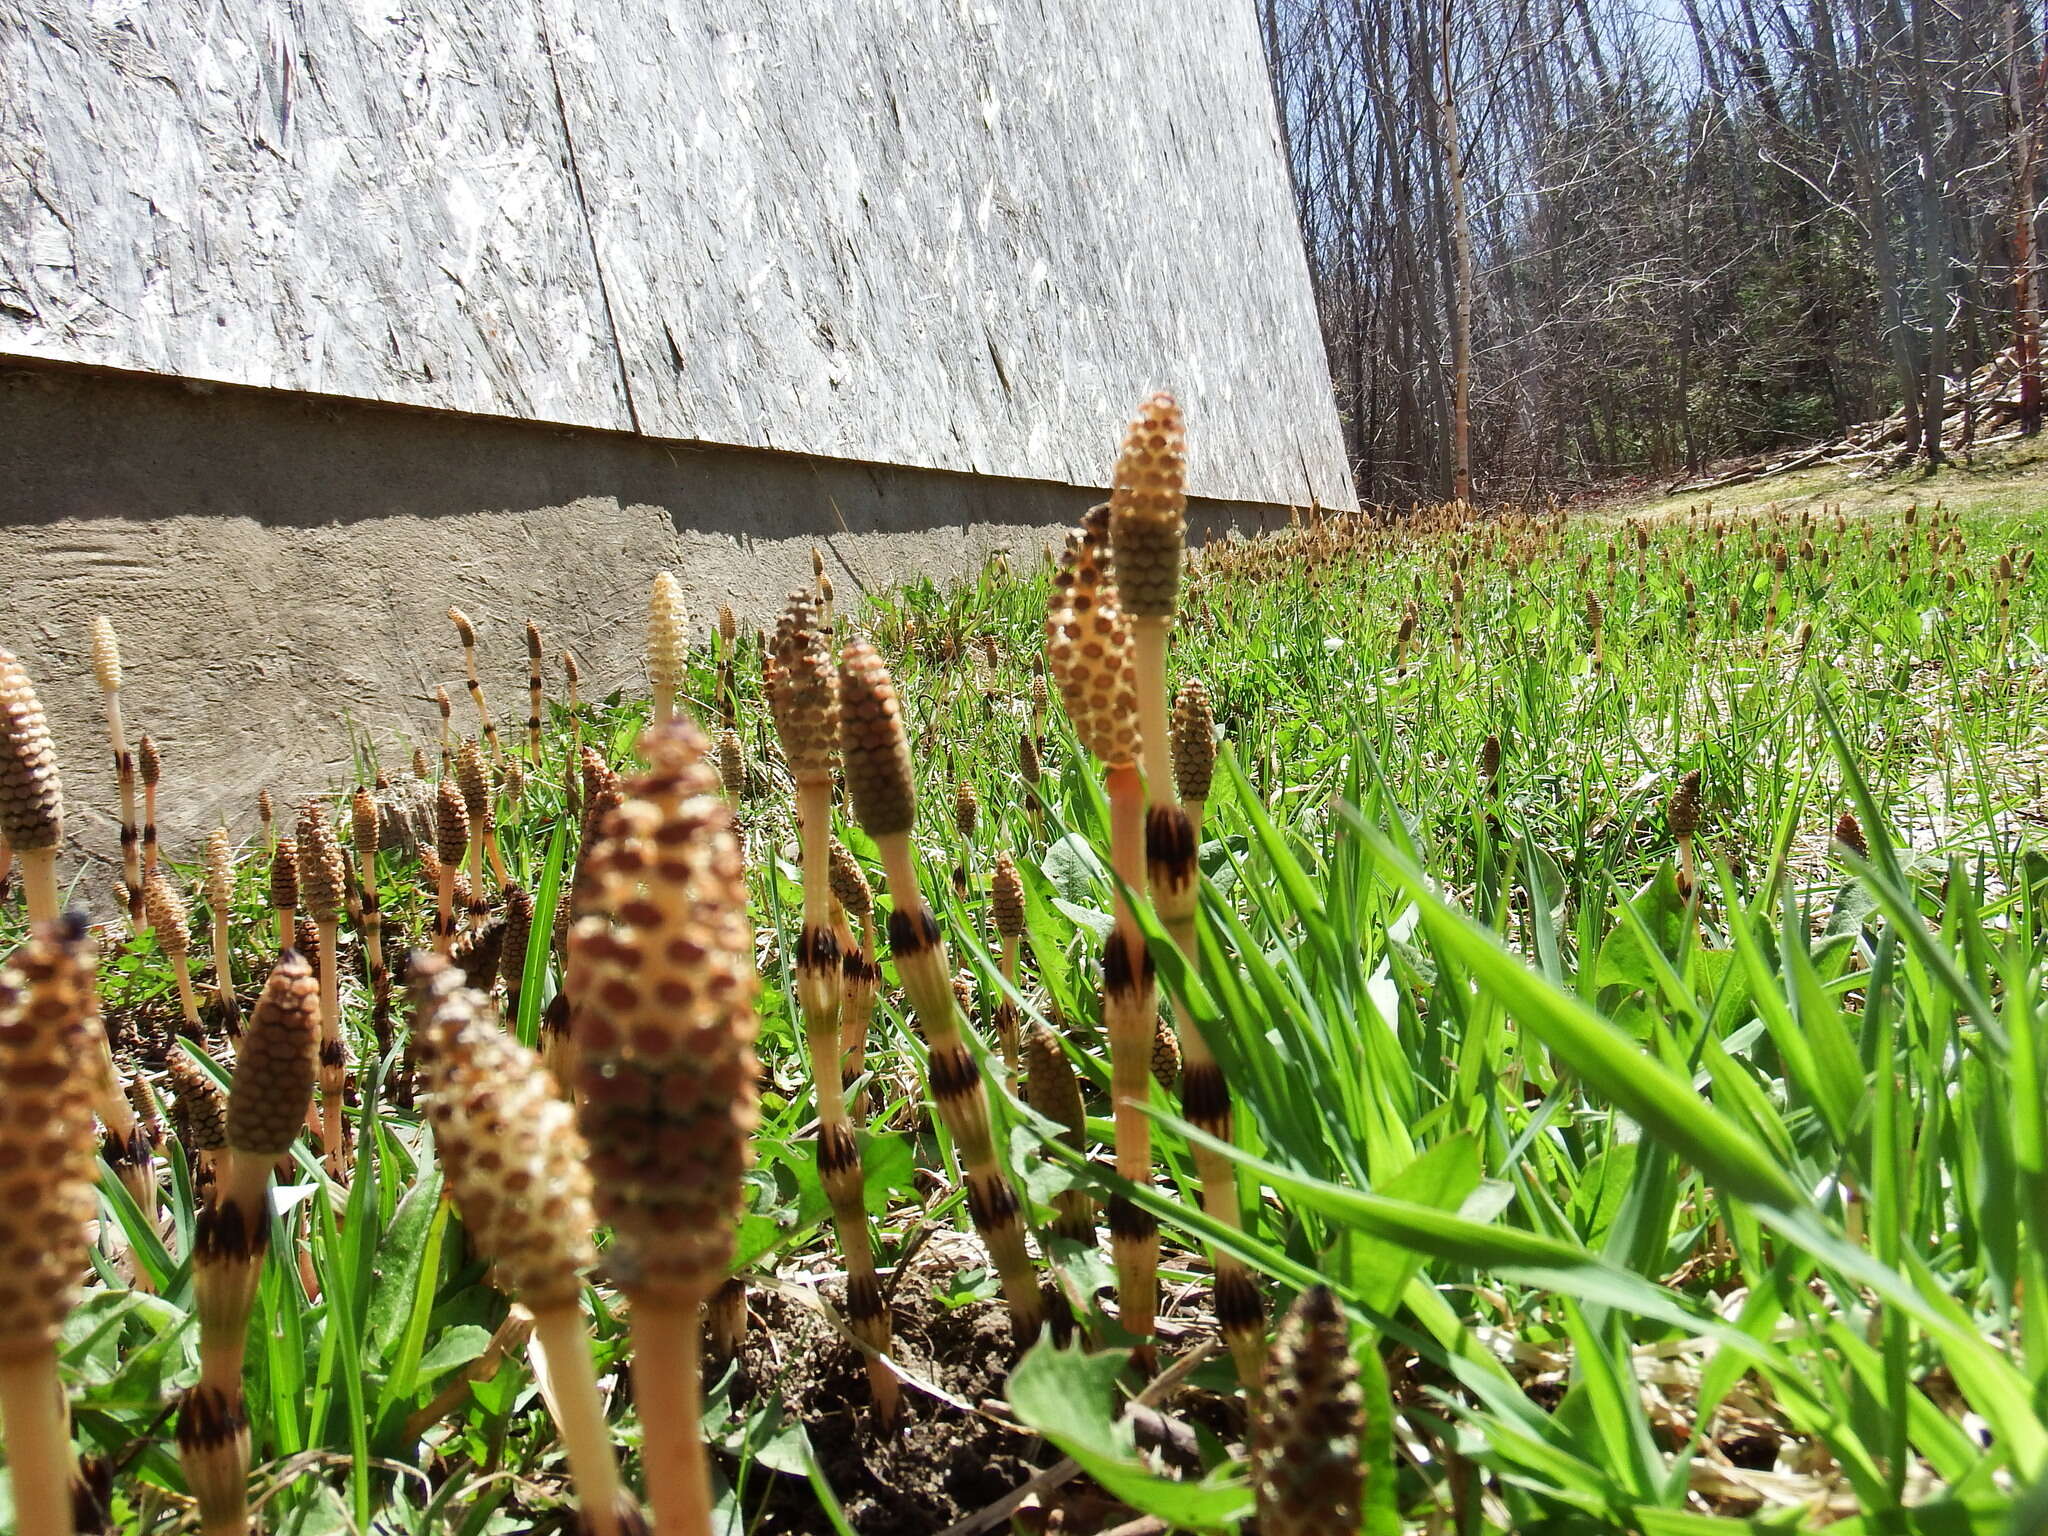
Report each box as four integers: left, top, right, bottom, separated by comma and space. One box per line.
0, 397, 2048, 1536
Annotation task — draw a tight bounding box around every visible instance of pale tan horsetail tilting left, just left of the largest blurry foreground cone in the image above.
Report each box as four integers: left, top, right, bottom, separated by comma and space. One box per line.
412, 954, 639, 1536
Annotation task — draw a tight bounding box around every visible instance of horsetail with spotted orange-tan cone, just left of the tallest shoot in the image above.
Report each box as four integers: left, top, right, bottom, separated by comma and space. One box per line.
1044, 506, 1171, 1364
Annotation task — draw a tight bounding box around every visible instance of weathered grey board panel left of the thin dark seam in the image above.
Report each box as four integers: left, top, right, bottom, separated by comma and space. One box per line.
0, 0, 627, 428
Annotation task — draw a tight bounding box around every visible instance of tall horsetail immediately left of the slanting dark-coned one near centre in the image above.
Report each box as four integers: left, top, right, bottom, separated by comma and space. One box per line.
770, 592, 899, 1421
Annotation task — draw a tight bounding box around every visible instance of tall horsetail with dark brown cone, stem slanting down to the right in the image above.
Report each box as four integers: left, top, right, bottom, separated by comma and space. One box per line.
840, 641, 1044, 1343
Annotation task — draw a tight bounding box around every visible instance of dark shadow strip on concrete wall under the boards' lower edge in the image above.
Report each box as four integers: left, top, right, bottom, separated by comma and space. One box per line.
0, 365, 1284, 581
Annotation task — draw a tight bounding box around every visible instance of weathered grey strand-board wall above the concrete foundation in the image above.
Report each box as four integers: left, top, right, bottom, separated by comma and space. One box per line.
0, 0, 1352, 506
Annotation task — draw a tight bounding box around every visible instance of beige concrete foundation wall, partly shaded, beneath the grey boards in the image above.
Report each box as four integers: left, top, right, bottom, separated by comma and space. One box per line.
0, 367, 1286, 884
